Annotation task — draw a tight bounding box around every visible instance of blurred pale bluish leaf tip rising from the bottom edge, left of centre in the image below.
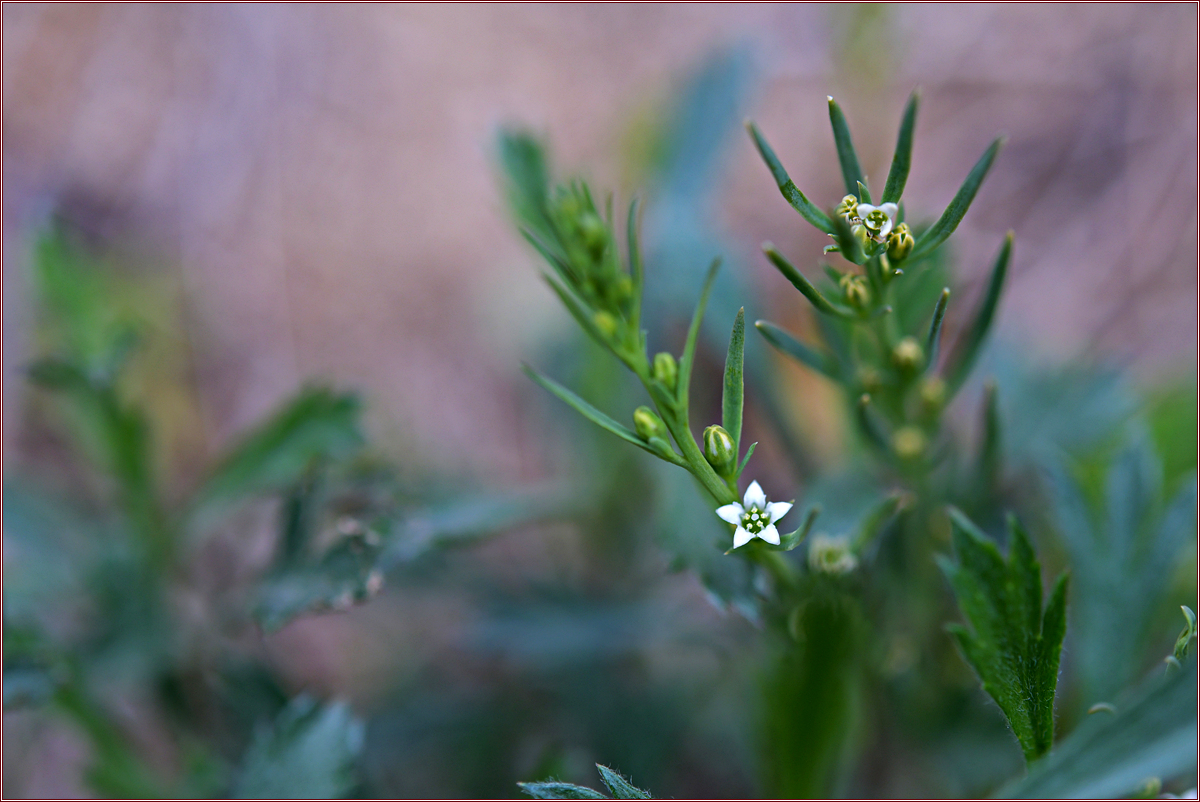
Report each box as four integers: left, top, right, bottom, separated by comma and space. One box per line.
234, 696, 362, 800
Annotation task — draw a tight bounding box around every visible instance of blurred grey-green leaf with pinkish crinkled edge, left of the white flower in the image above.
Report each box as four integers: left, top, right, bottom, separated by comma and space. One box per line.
254, 535, 383, 633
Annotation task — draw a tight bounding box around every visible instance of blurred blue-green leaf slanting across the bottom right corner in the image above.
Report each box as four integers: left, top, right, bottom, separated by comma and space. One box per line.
997, 660, 1196, 800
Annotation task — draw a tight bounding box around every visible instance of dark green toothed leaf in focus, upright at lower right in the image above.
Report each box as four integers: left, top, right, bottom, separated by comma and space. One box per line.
938, 508, 1067, 762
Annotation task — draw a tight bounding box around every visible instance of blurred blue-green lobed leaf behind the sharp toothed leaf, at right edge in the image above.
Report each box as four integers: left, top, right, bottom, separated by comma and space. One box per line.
1049, 437, 1196, 702
